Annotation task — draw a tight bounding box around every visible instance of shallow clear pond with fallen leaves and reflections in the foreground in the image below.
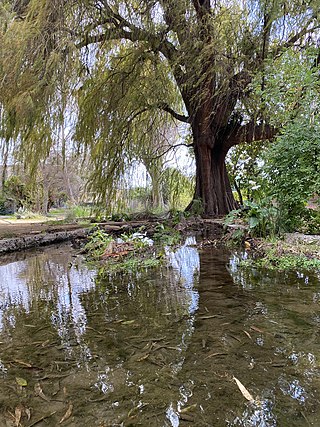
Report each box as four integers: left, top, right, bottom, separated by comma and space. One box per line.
0, 238, 320, 427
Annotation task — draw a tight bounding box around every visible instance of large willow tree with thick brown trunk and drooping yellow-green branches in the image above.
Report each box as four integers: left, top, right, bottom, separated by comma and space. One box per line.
1, 0, 319, 216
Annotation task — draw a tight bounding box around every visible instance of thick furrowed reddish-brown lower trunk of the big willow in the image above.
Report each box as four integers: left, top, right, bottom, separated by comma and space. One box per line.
187, 110, 238, 217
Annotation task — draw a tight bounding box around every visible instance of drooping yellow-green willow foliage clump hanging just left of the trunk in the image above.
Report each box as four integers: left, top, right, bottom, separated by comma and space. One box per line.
75, 44, 179, 206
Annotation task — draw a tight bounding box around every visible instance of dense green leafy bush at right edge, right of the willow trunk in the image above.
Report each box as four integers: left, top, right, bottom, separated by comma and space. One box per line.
265, 120, 320, 231
